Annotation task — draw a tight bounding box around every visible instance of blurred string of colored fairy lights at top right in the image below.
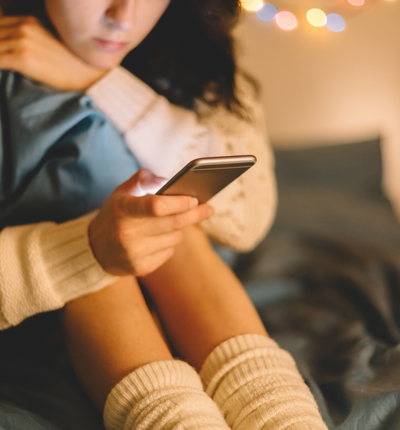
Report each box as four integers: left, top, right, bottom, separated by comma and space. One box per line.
240, 0, 397, 33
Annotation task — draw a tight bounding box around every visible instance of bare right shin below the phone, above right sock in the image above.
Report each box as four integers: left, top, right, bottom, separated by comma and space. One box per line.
143, 227, 267, 370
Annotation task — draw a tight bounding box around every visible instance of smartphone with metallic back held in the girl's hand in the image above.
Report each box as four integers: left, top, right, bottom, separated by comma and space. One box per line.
157, 155, 257, 203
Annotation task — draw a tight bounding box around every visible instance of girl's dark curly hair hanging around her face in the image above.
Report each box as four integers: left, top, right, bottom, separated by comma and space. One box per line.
0, 0, 245, 112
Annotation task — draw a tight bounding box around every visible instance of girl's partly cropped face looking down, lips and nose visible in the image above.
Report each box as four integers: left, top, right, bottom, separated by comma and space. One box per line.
45, 0, 170, 69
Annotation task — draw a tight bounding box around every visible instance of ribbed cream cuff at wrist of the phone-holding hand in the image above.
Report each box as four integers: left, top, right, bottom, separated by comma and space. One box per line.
40, 212, 118, 304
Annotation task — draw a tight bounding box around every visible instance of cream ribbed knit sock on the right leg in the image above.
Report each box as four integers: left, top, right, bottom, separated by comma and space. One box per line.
200, 335, 327, 430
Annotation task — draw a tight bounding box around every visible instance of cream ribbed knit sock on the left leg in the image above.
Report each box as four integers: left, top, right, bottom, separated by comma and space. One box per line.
104, 360, 229, 430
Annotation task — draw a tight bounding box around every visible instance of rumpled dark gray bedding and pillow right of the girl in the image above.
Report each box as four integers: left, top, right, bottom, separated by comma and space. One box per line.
237, 141, 400, 430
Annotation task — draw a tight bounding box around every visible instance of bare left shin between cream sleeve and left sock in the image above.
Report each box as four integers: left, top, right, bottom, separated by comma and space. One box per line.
61, 277, 172, 410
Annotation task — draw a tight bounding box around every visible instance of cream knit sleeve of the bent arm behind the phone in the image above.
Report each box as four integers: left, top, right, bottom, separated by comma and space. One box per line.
88, 67, 277, 251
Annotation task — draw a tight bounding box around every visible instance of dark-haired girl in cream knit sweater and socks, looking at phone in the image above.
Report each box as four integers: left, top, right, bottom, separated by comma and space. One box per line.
0, 0, 325, 429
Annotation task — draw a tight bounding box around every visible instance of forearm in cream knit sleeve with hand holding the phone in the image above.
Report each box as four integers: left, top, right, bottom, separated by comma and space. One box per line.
0, 170, 211, 330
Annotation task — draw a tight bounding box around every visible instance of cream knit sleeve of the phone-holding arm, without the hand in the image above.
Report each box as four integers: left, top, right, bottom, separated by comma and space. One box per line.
0, 213, 117, 330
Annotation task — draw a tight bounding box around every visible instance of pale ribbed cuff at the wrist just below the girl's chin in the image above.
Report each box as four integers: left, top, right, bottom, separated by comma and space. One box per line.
86, 67, 159, 134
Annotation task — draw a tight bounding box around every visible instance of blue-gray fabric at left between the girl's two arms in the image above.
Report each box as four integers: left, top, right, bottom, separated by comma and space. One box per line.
0, 71, 140, 228
